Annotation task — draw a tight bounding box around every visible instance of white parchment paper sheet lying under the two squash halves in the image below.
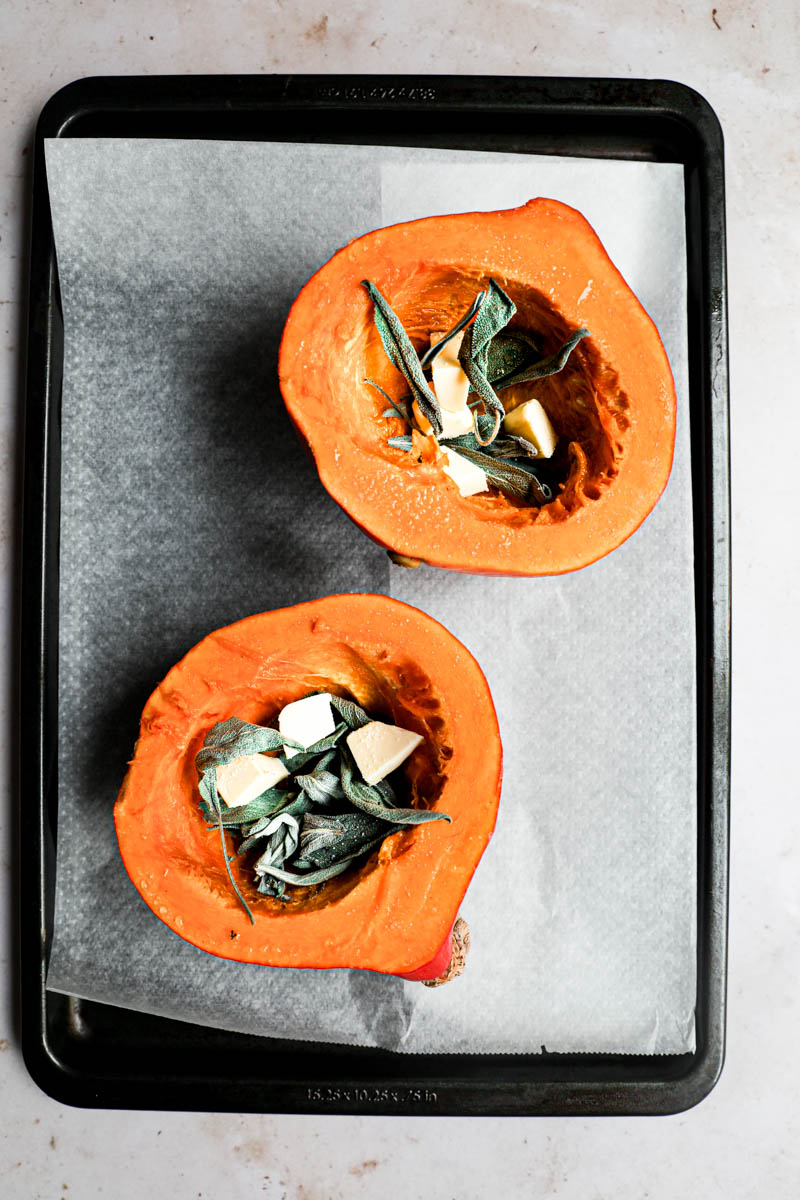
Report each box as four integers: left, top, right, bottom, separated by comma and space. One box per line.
47, 139, 696, 1054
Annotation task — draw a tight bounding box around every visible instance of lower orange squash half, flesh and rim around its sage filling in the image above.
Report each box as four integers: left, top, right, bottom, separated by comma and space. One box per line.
114, 594, 503, 978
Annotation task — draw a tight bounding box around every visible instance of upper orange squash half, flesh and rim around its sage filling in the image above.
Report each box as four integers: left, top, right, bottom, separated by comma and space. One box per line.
279, 199, 676, 576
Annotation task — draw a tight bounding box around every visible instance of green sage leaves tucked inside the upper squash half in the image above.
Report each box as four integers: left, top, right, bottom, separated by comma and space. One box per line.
362, 280, 589, 505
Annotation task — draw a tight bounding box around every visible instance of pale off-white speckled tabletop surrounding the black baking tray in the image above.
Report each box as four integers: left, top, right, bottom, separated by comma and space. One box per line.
0, 0, 800, 1200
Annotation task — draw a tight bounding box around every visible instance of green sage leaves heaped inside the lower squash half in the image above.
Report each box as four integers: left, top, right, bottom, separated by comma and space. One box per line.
196, 696, 451, 924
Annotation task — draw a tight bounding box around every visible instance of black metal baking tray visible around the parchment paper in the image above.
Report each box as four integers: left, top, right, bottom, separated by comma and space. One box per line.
19, 76, 730, 1116
